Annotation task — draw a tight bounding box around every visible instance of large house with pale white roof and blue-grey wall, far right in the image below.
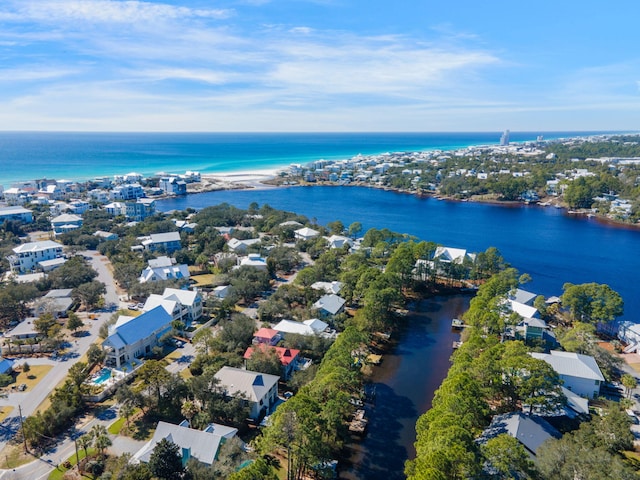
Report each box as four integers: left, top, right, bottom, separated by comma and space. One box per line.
530, 350, 604, 398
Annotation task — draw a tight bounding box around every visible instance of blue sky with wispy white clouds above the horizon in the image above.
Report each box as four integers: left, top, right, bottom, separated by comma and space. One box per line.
0, 0, 640, 132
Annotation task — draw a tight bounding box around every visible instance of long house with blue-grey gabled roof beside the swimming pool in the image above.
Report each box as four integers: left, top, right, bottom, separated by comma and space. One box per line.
101, 306, 173, 369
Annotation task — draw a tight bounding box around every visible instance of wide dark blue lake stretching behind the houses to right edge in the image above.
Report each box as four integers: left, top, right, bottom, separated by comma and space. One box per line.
158, 187, 640, 321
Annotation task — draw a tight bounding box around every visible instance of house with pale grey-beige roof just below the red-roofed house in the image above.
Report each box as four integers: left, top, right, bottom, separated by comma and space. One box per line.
214, 367, 280, 420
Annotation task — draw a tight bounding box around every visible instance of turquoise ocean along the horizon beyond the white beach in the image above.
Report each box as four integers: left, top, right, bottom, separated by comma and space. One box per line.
0, 132, 603, 188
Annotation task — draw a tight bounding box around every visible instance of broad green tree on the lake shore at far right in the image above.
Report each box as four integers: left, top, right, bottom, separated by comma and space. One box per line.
562, 283, 624, 323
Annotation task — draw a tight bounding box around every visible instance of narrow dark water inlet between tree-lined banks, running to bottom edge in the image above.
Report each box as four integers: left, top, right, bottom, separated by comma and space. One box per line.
340, 295, 471, 480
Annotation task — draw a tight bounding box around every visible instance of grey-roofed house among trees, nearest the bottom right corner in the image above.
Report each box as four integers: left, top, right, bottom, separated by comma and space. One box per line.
478, 412, 562, 458
